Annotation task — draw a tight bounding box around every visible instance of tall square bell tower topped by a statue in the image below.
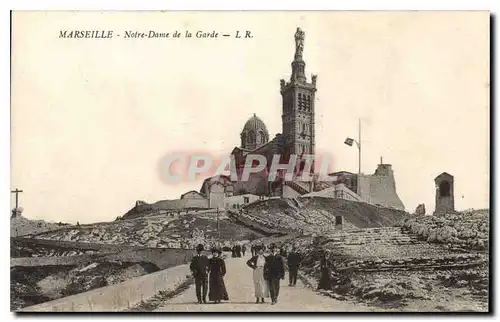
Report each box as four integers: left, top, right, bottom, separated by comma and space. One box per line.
280, 28, 316, 160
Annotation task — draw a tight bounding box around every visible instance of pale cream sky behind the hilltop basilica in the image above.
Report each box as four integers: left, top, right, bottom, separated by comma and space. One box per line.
11, 12, 490, 223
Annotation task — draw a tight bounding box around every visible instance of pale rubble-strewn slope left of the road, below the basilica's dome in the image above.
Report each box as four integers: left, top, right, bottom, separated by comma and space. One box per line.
27, 212, 263, 248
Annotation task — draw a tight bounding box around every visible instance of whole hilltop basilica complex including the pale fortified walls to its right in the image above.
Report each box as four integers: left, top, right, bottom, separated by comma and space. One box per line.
199, 28, 404, 209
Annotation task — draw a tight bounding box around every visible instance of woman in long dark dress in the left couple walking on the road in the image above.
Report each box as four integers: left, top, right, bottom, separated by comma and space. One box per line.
208, 249, 229, 303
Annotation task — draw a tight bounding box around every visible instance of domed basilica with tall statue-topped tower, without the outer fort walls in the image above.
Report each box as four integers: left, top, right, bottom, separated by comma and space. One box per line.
201, 28, 317, 196
